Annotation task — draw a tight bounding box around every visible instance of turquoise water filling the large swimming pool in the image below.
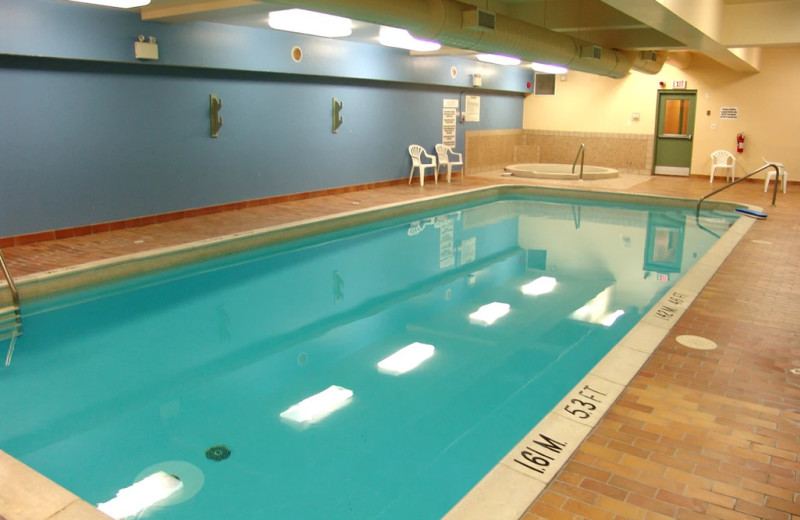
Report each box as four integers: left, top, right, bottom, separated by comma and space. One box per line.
0, 193, 735, 520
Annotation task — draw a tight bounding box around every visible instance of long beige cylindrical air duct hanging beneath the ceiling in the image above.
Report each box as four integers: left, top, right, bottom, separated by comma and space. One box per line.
260, 0, 648, 78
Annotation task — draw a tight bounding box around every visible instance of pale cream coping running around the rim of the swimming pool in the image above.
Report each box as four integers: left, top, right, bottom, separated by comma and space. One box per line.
0, 184, 762, 520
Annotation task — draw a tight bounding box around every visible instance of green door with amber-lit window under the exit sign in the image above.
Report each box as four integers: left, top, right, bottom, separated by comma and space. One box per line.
653, 91, 697, 176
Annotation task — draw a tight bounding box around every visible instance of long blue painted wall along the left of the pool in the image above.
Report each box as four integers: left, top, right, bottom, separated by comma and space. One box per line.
0, 0, 530, 236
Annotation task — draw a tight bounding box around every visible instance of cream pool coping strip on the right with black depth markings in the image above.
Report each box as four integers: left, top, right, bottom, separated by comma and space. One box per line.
443, 204, 761, 520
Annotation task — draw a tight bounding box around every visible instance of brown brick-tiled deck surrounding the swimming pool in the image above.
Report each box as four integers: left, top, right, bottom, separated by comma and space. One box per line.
0, 176, 800, 520
